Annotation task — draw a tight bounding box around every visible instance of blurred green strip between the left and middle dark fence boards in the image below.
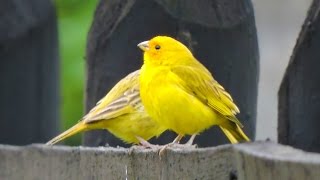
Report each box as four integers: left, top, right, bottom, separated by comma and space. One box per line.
55, 0, 97, 145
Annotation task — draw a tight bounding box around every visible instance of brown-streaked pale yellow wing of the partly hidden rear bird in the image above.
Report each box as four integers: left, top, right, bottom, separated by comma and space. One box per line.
82, 71, 142, 123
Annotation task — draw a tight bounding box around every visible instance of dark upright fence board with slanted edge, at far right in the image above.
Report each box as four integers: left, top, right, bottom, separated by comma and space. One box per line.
278, 0, 320, 152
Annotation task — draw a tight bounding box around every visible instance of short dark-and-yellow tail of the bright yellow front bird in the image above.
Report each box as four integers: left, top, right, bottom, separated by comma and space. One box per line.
220, 121, 250, 144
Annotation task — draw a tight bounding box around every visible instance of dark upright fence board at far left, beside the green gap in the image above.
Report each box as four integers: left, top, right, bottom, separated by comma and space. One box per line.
0, 0, 60, 145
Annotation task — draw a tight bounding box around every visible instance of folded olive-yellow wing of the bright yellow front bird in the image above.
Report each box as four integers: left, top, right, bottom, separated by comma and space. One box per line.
171, 64, 243, 127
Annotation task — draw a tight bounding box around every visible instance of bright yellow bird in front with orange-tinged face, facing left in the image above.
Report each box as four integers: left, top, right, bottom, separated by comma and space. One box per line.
138, 36, 250, 146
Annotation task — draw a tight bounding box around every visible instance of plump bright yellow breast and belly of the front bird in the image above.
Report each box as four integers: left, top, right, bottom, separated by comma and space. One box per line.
140, 64, 219, 135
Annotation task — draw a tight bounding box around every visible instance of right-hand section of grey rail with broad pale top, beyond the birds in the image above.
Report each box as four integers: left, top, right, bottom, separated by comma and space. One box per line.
235, 143, 320, 180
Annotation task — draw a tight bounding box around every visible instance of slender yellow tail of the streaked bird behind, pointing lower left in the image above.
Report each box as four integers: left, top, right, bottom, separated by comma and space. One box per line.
46, 121, 88, 145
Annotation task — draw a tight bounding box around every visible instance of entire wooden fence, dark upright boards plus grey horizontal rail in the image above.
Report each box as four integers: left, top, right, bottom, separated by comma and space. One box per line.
0, 0, 320, 180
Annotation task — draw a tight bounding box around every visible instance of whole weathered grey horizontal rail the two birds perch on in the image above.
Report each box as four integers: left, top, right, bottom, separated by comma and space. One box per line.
0, 142, 320, 180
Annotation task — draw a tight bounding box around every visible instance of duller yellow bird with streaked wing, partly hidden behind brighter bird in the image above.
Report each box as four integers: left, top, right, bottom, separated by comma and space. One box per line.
47, 70, 166, 147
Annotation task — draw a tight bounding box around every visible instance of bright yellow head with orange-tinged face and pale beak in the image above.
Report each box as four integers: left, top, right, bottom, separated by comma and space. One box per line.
138, 36, 193, 65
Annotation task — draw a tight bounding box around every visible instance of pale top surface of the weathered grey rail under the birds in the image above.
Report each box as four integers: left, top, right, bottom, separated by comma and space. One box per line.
0, 141, 320, 165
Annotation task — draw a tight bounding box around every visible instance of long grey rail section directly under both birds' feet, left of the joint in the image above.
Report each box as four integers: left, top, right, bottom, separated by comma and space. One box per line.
0, 145, 232, 180
